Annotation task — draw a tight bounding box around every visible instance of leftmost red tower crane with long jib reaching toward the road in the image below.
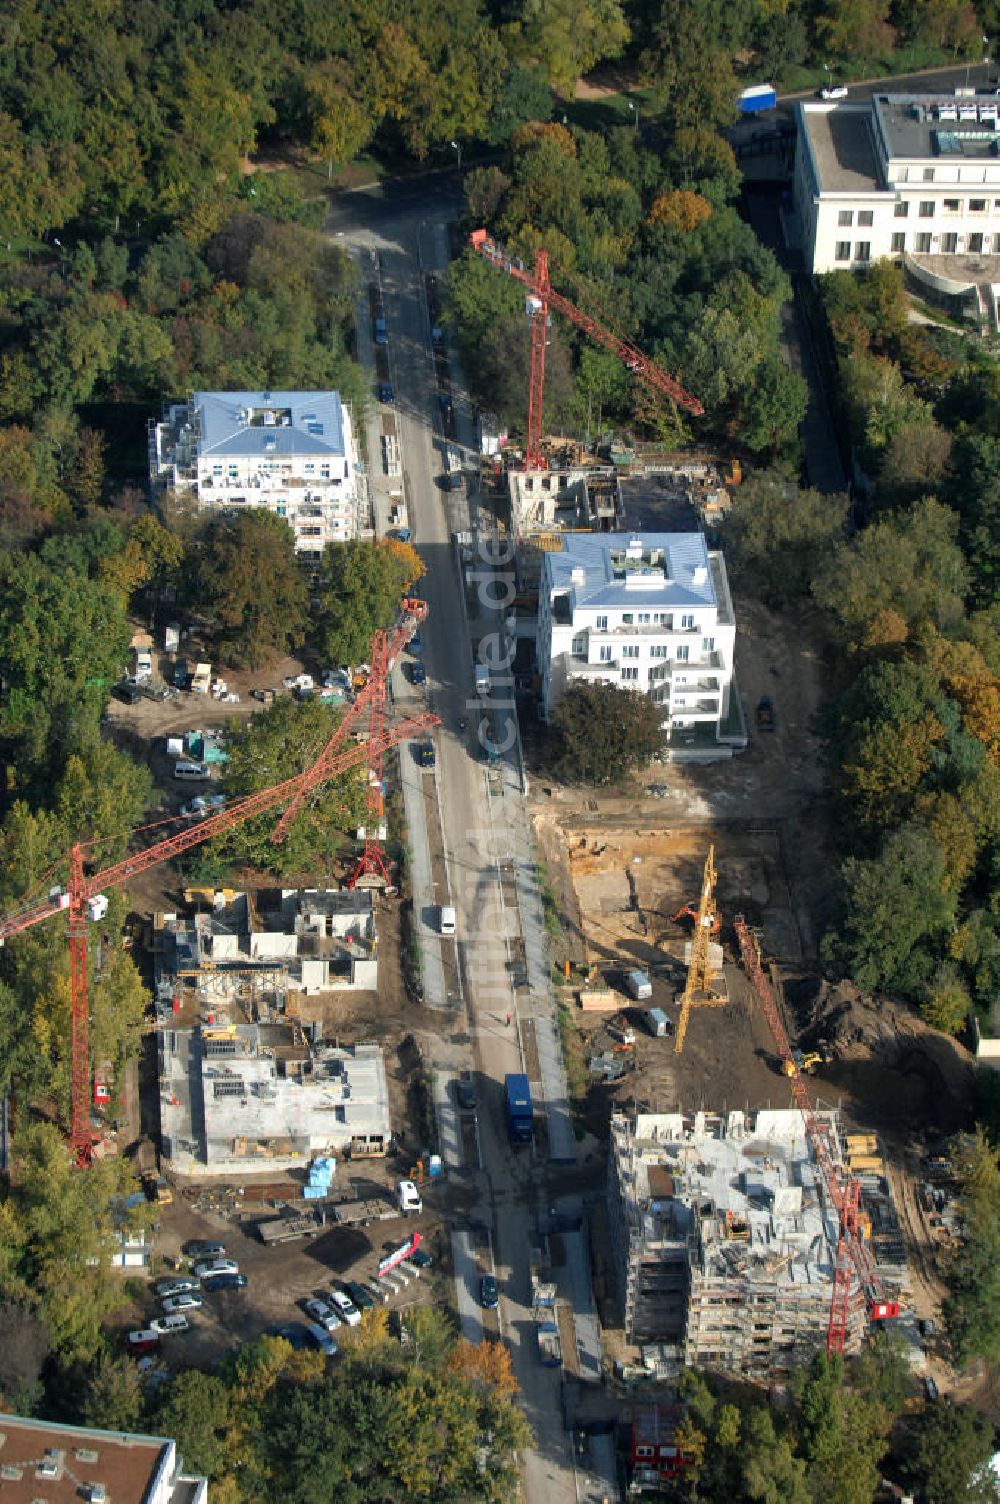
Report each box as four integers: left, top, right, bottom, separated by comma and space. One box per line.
0, 691, 441, 1166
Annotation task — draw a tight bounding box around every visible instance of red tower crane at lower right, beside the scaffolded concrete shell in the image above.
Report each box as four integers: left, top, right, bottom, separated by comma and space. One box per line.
734, 914, 899, 1354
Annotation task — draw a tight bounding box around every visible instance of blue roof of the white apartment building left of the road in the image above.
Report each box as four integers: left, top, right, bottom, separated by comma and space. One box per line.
192, 391, 344, 459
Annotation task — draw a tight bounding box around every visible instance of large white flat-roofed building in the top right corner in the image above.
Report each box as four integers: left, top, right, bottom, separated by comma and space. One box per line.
794, 93, 1000, 314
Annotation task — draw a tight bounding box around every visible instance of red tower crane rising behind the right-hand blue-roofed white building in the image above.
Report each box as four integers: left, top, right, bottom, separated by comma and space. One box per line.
469, 230, 705, 471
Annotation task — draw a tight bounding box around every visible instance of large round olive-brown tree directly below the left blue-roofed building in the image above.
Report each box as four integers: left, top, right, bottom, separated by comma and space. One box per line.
197, 508, 308, 668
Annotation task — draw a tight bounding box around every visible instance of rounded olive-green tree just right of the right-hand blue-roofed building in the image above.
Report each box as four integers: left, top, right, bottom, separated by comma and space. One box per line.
723, 471, 847, 606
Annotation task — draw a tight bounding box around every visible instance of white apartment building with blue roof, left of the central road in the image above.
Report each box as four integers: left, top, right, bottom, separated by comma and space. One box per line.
149, 391, 365, 556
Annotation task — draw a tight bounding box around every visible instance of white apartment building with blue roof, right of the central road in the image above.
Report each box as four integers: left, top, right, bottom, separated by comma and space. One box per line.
538, 532, 741, 740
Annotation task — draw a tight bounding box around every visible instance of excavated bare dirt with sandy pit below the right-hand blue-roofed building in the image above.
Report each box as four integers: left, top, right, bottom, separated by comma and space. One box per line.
532, 600, 986, 1393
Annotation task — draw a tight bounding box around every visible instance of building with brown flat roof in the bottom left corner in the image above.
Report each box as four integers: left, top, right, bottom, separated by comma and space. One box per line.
0, 1415, 208, 1504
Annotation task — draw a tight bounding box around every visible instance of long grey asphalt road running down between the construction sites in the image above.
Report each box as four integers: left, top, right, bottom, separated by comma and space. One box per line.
329, 184, 589, 1504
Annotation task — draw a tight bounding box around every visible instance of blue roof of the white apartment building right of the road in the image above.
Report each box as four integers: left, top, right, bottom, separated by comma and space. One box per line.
543, 532, 717, 611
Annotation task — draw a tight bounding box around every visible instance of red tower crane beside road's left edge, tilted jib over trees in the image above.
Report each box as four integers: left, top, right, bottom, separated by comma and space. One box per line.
272, 596, 427, 890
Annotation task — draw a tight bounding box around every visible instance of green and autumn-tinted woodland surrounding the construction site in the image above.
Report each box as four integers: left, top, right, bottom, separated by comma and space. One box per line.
0, 0, 1000, 1479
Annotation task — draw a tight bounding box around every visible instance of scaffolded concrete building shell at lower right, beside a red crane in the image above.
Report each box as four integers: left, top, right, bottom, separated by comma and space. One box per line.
609, 1108, 899, 1378
